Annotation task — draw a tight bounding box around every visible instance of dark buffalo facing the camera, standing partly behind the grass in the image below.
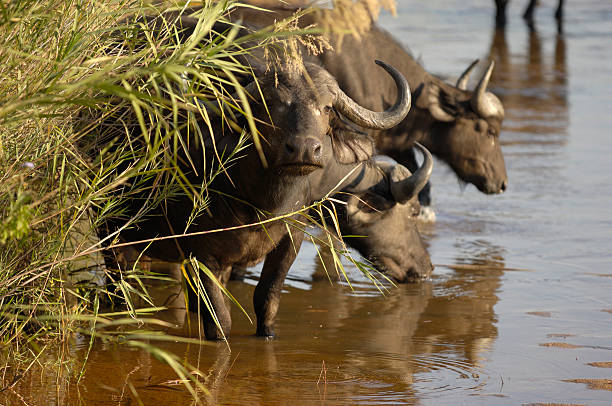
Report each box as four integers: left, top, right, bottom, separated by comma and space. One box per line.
94, 13, 428, 339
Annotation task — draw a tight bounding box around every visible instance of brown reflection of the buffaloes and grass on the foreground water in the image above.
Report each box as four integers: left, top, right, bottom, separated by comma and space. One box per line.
0, 241, 504, 405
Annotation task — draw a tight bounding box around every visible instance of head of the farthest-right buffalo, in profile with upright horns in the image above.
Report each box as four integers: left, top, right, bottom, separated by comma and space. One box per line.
416, 61, 508, 194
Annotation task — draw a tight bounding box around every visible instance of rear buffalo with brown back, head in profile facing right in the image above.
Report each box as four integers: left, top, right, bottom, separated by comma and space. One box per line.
233, 7, 508, 213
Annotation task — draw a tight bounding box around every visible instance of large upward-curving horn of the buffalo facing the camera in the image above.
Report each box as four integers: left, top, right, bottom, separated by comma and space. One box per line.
334, 61, 411, 130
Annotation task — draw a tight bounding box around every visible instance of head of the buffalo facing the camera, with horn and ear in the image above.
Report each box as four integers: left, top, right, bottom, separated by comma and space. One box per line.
246, 61, 410, 176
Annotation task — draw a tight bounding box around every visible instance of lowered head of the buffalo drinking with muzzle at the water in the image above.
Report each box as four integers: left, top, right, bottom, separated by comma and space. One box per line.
339, 143, 433, 282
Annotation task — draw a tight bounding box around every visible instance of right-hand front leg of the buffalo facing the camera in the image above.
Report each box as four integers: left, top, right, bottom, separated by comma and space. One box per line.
253, 229, 304, 337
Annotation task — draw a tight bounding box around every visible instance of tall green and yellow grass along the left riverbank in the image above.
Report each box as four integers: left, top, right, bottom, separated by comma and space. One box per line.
0, 0, 392, 396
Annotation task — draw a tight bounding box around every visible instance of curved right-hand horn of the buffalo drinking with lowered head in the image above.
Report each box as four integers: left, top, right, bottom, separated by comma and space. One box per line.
391, 142, 433, 203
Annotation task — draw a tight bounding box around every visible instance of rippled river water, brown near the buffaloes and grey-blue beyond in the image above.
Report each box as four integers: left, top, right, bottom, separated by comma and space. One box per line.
0, 0, 612, 405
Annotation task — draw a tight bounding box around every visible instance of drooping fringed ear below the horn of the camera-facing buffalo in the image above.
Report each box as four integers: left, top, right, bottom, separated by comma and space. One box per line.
332, 126, 374, 164
